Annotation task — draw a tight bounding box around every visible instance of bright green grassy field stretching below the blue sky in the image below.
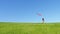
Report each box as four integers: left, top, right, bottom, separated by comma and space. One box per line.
0, 22, 60, 34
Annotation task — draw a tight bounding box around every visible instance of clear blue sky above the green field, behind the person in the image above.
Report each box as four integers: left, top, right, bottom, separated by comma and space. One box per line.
0, 0, 60, 22
